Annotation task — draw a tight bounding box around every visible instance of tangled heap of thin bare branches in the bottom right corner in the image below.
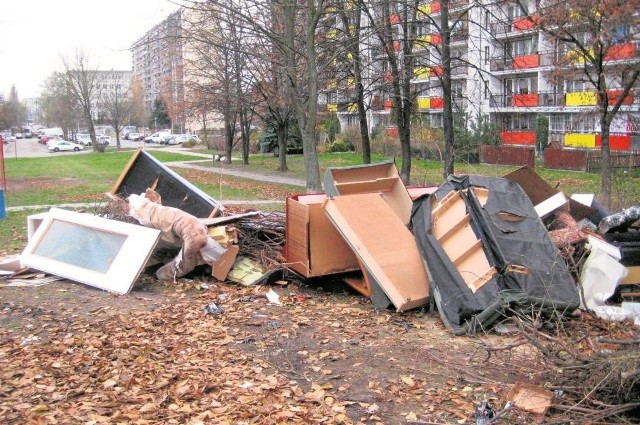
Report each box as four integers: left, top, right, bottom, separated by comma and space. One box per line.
478, 311, 640, 423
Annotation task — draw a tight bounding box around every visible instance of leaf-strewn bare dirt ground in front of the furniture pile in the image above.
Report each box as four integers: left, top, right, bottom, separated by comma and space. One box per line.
0, 264, 556, 424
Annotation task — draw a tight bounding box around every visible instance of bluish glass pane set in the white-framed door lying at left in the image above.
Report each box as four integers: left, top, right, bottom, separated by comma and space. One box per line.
33, 220, 127, 274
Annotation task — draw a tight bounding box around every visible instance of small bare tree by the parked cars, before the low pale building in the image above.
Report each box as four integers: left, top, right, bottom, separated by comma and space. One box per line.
60, 50, 106, 152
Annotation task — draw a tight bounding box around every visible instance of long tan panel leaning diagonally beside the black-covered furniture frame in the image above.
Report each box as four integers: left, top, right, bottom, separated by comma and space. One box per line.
324, 194, 429, 311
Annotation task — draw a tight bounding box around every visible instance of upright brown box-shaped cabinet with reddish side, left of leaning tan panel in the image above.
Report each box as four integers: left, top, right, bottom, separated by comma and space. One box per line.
284, 194, 360, 277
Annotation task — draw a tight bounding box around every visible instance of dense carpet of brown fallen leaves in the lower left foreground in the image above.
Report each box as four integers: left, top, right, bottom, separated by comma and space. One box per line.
0, 286, 347, 424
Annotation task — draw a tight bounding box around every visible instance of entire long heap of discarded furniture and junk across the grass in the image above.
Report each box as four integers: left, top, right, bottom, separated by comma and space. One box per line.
0, 149, 640, 334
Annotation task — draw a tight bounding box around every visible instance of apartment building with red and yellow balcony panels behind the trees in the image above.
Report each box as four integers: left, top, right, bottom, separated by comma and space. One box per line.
328, 0, 640, 150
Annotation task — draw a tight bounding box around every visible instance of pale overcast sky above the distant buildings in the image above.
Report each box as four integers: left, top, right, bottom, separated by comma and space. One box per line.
0, 0, 178, 100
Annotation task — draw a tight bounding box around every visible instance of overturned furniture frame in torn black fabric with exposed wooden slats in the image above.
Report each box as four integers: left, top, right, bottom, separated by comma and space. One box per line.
411, 176, 579, 334
